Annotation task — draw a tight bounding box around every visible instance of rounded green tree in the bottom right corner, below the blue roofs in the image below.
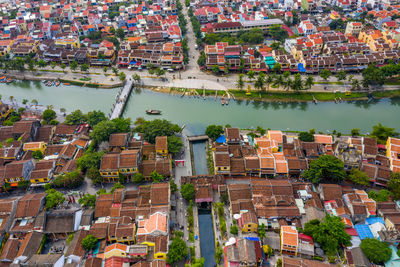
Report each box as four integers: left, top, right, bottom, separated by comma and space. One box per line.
360, 238, 392, 264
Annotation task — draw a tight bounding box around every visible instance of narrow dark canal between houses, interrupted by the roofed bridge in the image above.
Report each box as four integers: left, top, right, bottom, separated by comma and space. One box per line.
191, 141, 215, 267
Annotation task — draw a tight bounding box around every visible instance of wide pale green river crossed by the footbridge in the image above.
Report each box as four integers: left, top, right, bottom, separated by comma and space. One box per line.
0, 81, 400, 135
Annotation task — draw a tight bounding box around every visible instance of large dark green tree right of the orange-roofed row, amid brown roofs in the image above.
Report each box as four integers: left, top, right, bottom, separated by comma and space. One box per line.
303, 155, 346, 183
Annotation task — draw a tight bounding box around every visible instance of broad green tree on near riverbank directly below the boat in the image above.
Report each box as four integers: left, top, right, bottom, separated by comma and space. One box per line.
134, 119, 181, 144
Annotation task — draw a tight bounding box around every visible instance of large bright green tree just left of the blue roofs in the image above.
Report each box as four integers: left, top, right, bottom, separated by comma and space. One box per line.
303, 214, 351, 255
